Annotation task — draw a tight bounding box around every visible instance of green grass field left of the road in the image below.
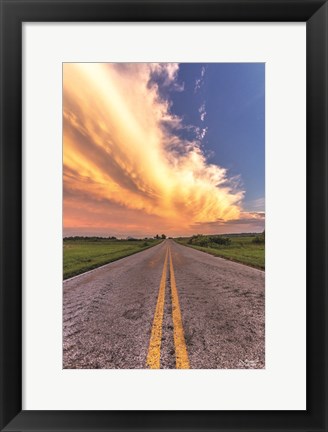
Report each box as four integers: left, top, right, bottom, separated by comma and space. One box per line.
63, 239, 161, 279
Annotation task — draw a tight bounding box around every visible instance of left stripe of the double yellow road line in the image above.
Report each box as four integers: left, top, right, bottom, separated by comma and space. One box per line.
147, 248, 168, 369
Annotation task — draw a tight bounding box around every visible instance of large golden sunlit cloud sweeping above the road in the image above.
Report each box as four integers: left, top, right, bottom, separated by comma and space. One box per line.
63, 63, 249, 235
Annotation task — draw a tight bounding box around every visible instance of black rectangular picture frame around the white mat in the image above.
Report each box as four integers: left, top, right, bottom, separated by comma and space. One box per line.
0, 0, 328, 432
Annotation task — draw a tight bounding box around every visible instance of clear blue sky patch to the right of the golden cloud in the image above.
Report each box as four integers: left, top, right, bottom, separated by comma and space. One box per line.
168, 63, 265, 211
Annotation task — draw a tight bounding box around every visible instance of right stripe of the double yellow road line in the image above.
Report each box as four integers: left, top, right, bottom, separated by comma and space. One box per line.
170, 249, 190, 369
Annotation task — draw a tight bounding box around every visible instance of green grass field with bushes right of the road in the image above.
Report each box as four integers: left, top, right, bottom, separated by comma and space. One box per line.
175, 235, 265, 270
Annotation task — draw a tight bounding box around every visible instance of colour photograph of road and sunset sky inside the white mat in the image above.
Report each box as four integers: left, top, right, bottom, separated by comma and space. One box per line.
63, 63, 265, 369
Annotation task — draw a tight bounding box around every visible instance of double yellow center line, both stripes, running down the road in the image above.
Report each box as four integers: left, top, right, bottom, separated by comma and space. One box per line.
147, 247, 190, 369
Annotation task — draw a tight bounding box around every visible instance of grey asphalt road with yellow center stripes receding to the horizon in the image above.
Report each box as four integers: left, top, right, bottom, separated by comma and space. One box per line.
63, 240, 265, 369
